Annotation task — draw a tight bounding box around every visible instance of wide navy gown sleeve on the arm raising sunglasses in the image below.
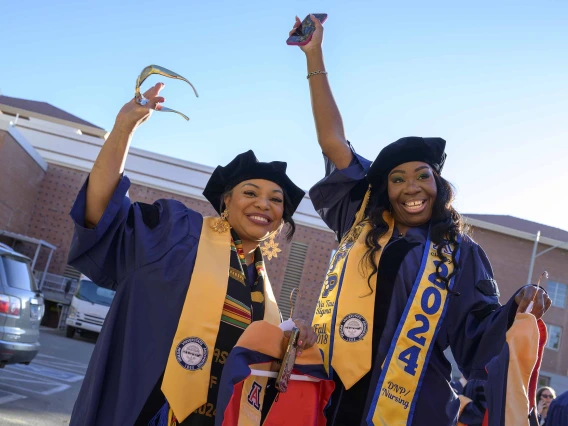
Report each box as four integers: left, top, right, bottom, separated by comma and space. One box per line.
68, 176, 203, 290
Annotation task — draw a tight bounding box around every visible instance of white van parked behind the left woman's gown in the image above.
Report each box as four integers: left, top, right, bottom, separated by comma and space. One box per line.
65, 275, 116, 338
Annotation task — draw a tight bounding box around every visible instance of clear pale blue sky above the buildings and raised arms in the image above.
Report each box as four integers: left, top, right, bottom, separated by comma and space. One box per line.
0, 0, 568, 229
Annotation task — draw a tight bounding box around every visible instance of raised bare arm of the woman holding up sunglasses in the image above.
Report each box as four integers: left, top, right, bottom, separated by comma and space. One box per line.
85, 83, 165, 228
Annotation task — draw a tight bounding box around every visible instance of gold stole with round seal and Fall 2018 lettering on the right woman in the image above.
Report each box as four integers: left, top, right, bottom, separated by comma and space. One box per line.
312, 190, 394, 389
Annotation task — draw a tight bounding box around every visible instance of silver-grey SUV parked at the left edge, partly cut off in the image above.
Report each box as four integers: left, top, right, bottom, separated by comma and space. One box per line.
0, 243, 45, 368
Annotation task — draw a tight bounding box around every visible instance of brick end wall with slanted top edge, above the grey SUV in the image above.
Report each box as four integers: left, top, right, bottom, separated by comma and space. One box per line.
0, 130, 45, 235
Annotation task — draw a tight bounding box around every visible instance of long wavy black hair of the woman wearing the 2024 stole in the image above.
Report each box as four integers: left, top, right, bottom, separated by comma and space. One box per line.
361, 171, 467, 295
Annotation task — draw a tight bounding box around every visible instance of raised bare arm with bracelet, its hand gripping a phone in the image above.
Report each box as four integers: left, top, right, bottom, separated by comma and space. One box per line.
290, 15, 353, 170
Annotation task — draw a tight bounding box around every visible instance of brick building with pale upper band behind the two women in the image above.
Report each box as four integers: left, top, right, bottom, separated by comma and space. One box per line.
0, 96, 568, 391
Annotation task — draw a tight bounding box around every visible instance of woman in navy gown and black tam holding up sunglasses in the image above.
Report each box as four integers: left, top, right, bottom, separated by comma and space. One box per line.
69, 84, 315, 426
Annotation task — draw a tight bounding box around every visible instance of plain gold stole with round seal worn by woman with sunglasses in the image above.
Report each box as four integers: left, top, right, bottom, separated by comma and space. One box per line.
162, 217, 280, 423
